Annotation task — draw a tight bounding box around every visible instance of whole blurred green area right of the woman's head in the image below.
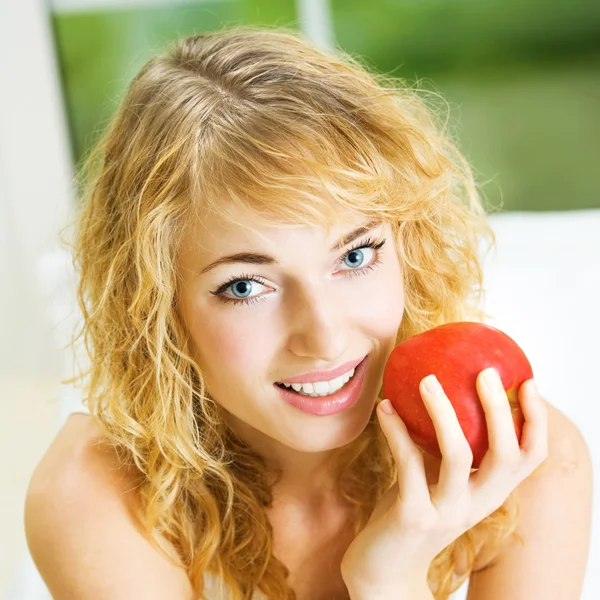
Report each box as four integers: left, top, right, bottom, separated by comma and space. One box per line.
332, 0, 600, 210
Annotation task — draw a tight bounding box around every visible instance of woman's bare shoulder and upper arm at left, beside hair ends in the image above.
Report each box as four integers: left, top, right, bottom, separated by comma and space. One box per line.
25, 414, 194, 600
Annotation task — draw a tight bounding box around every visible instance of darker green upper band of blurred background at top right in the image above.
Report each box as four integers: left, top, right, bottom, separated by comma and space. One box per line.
330, 0, 600, 77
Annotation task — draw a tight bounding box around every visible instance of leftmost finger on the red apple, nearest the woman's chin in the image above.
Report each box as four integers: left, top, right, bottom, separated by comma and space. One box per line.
377, 399, 431, 507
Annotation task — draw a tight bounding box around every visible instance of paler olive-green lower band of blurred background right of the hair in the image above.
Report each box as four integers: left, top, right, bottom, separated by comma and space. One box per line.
435, 59, 600, 211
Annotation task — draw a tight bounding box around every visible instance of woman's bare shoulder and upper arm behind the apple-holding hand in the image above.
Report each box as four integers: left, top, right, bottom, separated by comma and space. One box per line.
467, 404, 593, 600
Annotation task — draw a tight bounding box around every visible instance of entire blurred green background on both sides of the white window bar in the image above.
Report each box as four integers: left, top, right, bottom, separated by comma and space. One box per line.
52, 0, 600, 211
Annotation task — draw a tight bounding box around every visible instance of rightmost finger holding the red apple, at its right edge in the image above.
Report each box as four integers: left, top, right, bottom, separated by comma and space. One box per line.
519, 379, 548, 467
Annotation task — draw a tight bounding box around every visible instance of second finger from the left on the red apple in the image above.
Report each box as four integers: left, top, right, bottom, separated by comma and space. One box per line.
419, 375, 473, 505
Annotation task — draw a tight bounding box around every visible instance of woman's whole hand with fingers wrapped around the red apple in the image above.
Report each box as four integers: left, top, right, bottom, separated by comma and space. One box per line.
341, 369, 548, 598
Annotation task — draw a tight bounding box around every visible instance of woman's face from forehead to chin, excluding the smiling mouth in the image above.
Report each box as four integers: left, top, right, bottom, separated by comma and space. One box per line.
179, 207, 404, 452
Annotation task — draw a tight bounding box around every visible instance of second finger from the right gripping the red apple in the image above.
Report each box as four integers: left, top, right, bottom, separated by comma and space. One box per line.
472, 368, 522, 487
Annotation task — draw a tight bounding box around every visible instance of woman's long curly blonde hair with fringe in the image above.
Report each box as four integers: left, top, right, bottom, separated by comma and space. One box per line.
68, 26, 517, 600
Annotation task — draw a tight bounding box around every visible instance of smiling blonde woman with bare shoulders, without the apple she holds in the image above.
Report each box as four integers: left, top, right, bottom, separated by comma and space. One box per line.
26, 27, 591, 600
